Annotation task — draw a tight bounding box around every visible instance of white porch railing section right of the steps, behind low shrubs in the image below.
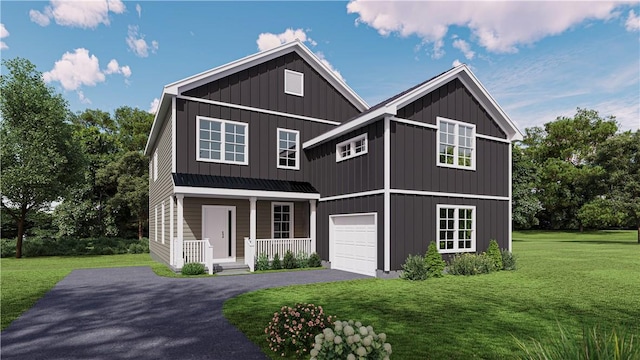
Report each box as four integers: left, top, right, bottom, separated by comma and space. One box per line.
244, 238, 315, 271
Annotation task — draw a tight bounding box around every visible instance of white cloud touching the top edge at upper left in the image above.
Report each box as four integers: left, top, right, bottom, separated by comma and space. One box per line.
29, 0, 125, 29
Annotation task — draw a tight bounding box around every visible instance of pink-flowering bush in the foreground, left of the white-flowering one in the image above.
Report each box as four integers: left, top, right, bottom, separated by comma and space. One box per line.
264, 304, 332, 358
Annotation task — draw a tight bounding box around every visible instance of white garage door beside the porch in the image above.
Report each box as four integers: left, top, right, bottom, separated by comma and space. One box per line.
329, 213, 378, 276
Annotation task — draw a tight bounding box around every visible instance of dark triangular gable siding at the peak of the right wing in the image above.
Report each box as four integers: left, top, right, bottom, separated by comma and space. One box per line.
397, 79, 507, 139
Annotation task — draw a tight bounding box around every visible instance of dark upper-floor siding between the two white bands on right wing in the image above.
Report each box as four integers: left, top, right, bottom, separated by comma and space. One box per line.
391, 121, 509, 196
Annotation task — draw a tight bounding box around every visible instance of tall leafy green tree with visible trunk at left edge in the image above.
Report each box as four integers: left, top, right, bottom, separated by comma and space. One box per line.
0, 58, 84, 258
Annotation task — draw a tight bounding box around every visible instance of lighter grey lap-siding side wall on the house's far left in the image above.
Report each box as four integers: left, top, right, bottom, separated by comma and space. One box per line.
149, 113, 173, 264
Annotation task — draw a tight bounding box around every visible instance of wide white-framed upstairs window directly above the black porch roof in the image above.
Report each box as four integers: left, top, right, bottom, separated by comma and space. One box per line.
196, 116, 249, 165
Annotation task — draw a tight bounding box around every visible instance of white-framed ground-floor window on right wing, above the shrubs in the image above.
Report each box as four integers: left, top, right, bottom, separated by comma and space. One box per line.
436, 204, 476, 253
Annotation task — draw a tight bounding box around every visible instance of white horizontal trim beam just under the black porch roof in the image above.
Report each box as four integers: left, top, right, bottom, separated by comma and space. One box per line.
173, 186, 320, 200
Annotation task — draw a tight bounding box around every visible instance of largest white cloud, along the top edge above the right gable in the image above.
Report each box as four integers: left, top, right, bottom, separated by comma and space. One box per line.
347, 0, 623, 55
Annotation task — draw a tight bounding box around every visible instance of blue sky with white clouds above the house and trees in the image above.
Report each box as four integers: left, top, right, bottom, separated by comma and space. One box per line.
0, 0, 640, 131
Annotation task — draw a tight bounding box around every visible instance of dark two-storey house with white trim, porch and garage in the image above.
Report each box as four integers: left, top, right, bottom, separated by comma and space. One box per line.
145, 41, 522, 276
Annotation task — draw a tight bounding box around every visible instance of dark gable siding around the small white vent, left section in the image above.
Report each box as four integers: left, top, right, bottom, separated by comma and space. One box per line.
184, 52, 359, 122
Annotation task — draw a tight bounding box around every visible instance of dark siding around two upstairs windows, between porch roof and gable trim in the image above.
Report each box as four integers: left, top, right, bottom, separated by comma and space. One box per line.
176, 99, 334, 181
